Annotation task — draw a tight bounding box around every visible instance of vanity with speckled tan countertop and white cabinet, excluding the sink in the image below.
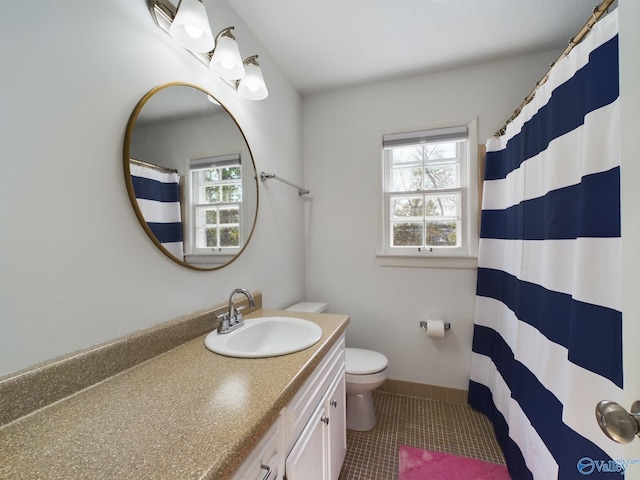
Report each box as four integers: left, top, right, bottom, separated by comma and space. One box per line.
0, 309, 349, 480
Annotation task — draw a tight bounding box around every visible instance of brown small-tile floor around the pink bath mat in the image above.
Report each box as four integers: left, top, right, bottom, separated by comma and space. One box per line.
339, 391, 504, 480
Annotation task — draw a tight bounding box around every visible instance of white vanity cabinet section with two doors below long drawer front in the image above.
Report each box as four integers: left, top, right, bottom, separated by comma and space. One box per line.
285, 337, 347, 480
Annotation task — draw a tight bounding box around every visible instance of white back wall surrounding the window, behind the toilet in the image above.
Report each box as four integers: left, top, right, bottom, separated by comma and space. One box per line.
304, 51, 560, 389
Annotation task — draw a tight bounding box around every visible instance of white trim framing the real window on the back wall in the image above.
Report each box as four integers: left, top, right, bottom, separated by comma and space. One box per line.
375, 117, 479, 269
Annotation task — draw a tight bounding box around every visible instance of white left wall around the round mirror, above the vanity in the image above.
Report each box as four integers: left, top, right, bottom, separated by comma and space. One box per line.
0, 0, 304, 375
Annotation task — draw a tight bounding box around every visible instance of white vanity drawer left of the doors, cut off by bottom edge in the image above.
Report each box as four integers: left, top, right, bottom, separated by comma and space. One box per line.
231, 414, 283, 480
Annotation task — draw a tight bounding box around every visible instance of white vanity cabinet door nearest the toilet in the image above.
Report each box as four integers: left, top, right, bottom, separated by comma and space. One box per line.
326, 372, 347, 480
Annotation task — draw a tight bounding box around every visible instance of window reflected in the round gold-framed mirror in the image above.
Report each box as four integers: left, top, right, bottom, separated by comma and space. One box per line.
189, 154, 243, 254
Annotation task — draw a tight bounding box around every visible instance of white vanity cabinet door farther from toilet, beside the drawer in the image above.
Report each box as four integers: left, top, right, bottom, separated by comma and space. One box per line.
285, 405, 327, 480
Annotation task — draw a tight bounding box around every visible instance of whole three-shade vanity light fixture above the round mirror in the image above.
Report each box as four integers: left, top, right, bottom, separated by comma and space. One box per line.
147, 0, 269, 100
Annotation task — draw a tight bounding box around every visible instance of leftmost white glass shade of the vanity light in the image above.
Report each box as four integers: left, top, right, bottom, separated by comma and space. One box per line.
169, 0, 214, 52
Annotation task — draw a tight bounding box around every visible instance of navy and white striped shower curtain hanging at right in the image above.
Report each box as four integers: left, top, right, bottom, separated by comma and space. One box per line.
469, 11, 623, 480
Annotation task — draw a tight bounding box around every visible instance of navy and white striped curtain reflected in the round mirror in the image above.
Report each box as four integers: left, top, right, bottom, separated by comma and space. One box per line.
130, 162, 184, 260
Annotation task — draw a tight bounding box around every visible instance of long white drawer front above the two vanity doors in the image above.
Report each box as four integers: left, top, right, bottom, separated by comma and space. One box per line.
285, 334, 344, 448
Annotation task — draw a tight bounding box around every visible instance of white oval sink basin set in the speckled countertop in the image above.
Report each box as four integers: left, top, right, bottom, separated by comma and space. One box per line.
204, 317, 322, 358
